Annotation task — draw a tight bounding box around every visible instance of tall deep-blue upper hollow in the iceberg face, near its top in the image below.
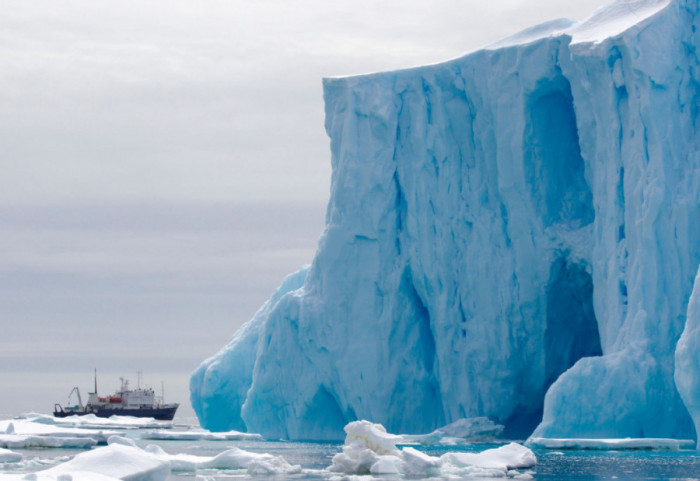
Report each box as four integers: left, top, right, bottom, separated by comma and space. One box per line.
523, 73, 595, 227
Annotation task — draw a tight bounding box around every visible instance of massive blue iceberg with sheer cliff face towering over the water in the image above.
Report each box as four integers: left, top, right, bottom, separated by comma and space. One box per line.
190, 0, 700, 439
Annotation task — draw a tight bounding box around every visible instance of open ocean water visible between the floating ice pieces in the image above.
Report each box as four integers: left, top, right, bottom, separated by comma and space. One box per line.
0, 430, 700, 481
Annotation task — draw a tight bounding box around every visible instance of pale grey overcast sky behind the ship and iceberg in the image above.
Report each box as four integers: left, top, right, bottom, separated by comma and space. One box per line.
0, 0, 605, 416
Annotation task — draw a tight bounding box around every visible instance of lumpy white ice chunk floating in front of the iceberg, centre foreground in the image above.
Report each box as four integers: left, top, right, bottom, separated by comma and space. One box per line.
328, 420, 537, 477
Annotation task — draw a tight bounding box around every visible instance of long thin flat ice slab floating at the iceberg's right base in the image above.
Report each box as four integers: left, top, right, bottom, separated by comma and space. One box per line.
526, 438, 695, 451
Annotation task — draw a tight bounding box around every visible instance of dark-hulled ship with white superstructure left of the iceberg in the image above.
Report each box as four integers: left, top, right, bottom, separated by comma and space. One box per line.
53, 370, 179, 421
